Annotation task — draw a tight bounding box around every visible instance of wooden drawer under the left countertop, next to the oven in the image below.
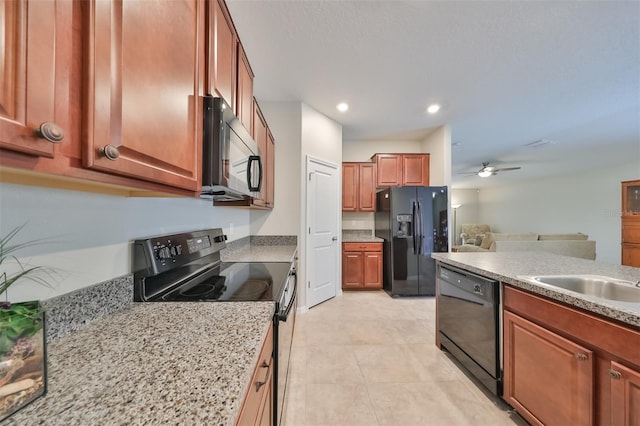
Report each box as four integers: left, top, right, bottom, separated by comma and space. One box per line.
236, 328, 273, 425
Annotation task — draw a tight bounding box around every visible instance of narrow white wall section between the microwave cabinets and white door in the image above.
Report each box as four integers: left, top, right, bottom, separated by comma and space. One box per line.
251, 102, 302, 235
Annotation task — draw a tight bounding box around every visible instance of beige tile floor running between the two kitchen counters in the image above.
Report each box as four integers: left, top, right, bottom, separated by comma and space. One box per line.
284, 291, 526, 426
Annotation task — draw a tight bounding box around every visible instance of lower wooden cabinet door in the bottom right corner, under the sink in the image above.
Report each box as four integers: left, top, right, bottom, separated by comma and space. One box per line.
609, 362, 640, 426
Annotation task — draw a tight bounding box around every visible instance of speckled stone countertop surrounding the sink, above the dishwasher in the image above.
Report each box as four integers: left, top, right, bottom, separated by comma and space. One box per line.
431, 252, 640, 328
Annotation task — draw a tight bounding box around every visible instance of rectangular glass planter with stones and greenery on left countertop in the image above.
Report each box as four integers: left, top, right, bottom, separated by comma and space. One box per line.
0, 301, 47, 421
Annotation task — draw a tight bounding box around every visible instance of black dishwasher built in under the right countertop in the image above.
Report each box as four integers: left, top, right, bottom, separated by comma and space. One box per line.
436, 264, 502, 396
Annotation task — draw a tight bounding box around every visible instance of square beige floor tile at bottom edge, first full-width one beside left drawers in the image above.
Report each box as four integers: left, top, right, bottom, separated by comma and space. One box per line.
304, 384, 378, 426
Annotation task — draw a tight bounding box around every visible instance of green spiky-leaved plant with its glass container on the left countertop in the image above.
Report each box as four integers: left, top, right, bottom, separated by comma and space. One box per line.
0, 225, 51, 421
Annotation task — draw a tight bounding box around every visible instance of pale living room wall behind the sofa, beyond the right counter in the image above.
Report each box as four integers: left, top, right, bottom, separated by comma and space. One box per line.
478, 161, 640, 264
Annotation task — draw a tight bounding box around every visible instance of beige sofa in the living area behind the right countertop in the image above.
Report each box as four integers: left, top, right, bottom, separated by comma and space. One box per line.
457, 232, 596, 260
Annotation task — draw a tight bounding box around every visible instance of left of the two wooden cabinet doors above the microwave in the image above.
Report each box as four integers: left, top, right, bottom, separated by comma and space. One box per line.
206, 0, 238, 111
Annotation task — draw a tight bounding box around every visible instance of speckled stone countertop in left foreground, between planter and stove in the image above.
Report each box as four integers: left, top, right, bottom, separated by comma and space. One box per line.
4, 302, 274, 426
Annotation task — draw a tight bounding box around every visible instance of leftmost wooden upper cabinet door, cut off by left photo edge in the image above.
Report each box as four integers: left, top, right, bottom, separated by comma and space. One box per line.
0, 0, 72, 158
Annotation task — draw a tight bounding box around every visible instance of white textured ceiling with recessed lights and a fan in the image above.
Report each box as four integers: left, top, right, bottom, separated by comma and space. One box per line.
227, 0, 640, 188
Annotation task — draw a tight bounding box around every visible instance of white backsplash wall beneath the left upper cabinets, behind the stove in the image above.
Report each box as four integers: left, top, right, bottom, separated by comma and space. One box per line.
0, 184, 250, 301
